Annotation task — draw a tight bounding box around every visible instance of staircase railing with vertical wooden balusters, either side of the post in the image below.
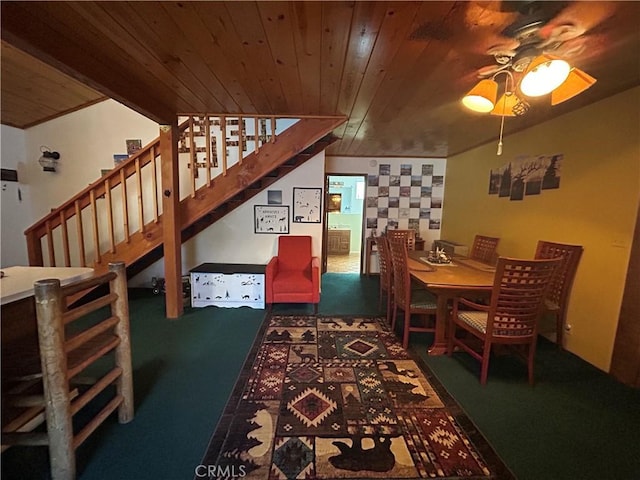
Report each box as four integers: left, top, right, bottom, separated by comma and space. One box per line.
25, 115, 296, 267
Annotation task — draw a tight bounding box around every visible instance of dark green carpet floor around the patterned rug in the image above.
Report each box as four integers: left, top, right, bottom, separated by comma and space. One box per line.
2, 274, 640, 480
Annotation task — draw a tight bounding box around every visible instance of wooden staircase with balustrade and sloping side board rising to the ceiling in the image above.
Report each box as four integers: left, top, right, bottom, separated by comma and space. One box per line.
25, 115, 344, 276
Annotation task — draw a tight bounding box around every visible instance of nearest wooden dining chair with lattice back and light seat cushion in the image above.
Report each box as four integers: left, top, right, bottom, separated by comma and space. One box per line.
448, 257, 561, 385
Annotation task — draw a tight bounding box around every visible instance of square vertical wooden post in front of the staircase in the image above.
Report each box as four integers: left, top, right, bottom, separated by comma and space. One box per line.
160, 121, 184, 318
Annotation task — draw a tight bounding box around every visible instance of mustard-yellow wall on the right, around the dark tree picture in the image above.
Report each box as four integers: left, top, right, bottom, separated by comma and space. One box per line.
442, 88, 640, 371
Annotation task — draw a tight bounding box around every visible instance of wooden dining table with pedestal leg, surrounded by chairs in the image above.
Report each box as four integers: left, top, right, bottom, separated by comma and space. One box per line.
407, 251, 496, 355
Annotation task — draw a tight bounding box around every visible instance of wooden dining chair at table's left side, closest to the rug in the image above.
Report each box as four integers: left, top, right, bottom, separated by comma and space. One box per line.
388, 237, 438, 348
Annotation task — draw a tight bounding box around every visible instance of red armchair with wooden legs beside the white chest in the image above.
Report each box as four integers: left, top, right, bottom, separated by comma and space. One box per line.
265, 235, 320, 313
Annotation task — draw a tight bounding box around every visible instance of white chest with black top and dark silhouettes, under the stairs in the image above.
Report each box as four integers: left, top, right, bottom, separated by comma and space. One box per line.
190, 263, 265, 308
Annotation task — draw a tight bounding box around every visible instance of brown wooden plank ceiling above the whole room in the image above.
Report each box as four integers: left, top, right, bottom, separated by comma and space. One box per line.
1, 1, 640, 157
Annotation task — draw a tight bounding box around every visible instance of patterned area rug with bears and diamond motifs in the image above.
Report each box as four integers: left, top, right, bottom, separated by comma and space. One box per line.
196, 315, 514, 480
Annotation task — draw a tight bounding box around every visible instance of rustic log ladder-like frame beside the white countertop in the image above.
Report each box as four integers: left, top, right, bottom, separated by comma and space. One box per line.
2, 262, 134, 480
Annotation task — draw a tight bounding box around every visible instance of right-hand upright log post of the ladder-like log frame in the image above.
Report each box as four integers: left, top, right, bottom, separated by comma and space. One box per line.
109, 262, 133, 423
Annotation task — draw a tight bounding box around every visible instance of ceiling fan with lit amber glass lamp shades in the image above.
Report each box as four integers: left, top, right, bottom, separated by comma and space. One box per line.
462, 1, 610, 117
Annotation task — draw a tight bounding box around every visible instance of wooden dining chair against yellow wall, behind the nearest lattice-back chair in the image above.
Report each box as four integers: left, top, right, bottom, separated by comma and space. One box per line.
535, 240, 584, 348
